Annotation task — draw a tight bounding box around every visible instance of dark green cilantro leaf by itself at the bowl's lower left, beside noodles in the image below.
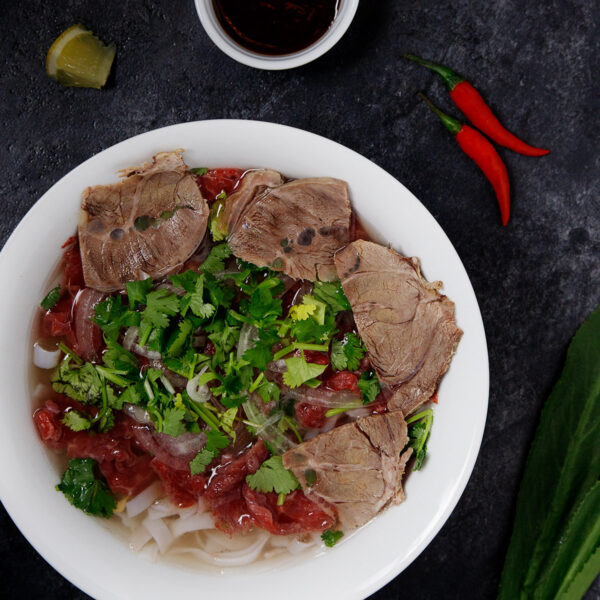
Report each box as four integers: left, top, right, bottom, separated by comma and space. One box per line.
56, 458, 117, 518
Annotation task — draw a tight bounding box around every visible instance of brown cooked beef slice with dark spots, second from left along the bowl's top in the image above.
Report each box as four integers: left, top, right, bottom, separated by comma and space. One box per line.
228, 171, 350, 281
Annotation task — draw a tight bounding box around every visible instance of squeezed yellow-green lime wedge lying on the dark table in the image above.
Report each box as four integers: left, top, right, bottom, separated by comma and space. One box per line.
46, 24, 116, 89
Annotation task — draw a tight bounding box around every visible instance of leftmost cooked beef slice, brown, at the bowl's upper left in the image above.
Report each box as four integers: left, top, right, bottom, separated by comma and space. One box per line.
79, 151, 209, 292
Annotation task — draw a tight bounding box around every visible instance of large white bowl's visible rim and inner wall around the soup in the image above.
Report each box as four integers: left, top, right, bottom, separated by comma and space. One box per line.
0, 121, 488, 600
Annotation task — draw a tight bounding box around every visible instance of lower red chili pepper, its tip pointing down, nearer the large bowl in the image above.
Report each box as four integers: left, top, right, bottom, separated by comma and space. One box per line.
419, 94, 510, 225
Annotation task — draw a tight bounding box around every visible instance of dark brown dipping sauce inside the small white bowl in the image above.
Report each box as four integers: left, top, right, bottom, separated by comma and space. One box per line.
213, 0, 340, 56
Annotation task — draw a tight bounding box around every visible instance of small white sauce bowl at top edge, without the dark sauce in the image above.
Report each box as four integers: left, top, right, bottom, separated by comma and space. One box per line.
195, 0, 358, 71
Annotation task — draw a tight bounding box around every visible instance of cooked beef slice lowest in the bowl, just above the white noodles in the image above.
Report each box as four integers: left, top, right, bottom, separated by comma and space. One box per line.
283, 411, 412, 529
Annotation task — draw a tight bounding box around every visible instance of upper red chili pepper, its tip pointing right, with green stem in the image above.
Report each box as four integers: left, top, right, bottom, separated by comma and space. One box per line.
404, 54, 550, 156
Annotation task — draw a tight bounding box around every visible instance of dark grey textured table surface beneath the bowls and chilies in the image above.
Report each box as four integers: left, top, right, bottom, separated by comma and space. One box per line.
0, 0, 600, 600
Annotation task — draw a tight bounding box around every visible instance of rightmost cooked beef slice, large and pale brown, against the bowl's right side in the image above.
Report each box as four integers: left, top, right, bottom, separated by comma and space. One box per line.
335, 240, 462, 415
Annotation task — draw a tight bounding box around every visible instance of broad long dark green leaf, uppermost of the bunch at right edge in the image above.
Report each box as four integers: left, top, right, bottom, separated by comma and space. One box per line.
498, 307, 600, 600
